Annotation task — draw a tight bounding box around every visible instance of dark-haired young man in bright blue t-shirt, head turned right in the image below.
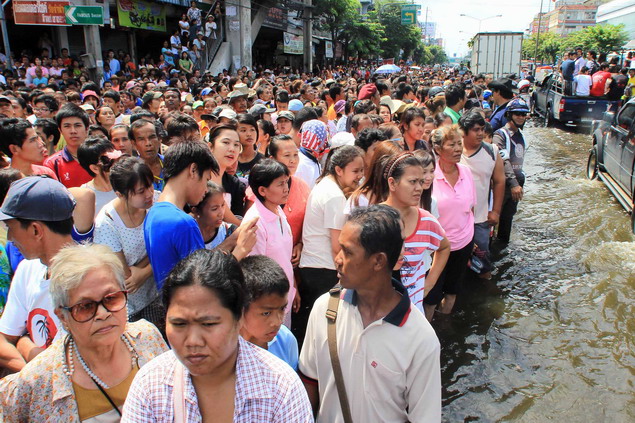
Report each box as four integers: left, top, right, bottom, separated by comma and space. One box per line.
143, 141, 219, 289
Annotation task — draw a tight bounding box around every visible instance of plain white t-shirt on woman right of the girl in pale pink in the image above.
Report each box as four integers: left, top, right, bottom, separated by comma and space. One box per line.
296, 173, 346, 270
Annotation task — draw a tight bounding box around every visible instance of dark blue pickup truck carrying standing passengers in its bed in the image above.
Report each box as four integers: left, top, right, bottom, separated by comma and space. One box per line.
532, 73, 618, 126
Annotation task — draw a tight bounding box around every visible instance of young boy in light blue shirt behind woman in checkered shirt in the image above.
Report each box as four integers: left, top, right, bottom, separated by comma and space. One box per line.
240, 255, 298, 370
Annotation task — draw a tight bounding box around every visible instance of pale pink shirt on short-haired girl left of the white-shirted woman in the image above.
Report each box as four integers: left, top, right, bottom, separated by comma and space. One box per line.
243, 200, 295, 315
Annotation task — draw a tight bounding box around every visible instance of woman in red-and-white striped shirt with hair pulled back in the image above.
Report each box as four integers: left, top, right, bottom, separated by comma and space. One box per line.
384, 152, 450, 320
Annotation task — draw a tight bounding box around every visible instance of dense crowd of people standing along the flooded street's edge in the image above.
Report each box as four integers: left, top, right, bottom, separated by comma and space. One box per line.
0, 48, 540, 422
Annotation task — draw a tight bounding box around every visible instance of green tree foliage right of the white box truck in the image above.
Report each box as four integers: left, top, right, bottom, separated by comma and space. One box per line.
522, 24, 628, 63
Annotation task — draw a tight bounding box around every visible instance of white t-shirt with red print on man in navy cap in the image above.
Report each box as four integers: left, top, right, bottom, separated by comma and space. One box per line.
0, 259, 64, 347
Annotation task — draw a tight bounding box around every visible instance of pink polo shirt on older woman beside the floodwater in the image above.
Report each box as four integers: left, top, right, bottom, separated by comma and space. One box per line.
432, 162, 476, 251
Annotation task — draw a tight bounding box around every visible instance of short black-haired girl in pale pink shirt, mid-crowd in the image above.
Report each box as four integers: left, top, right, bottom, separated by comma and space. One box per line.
243, 159, 296, 328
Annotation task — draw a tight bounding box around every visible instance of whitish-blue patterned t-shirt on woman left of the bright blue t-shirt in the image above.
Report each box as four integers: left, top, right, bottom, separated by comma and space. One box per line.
94, 202, 158, 314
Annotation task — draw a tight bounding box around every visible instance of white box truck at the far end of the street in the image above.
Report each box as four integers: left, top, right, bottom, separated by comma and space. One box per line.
470, 32, 523, 79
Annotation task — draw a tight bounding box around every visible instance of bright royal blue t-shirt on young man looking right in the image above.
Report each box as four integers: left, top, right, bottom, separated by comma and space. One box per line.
143, 201, 205, 289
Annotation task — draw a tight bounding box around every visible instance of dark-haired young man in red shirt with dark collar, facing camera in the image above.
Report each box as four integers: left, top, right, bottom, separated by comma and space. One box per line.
44, 103, 93, 188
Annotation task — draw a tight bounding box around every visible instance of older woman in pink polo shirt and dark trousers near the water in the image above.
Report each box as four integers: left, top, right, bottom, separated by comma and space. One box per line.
426, 125, 476, 314
